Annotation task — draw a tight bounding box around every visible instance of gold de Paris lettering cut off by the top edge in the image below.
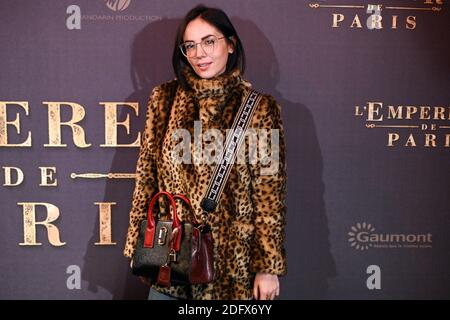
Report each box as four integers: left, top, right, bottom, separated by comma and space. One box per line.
307, 0, 446, 31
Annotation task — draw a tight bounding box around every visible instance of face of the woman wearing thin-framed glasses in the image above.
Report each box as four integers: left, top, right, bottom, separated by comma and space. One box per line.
183, 17, 233, 79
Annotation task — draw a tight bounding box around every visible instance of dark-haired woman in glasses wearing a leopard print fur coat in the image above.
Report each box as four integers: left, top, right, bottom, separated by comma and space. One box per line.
124, 6, 286, 300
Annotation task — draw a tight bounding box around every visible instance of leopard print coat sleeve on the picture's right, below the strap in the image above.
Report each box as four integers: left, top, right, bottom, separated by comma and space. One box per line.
250, 96, 287, 275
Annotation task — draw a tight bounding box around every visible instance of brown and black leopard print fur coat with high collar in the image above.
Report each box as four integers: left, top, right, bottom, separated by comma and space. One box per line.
124, 68, 286, 299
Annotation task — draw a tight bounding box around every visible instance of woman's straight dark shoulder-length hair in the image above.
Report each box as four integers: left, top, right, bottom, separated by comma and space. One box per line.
172, 5, 245, 90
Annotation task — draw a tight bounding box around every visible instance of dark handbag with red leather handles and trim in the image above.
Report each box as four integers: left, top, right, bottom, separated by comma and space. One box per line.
132, 191, 214, 286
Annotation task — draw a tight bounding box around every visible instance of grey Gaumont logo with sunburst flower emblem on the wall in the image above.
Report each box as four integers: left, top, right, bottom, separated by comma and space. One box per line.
347, 222, 432, 251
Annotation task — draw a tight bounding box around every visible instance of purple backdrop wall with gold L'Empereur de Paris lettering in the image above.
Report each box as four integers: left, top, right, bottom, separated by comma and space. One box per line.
0, 0, 450, 299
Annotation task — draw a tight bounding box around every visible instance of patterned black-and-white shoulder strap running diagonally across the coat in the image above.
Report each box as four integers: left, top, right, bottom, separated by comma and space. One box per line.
201, 89, 262, 219
